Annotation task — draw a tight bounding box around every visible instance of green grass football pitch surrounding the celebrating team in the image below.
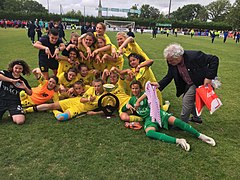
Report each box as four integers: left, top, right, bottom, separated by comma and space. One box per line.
0, 29, 240, 179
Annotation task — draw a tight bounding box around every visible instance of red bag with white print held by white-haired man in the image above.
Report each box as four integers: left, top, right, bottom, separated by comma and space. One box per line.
196, 84, 222, 116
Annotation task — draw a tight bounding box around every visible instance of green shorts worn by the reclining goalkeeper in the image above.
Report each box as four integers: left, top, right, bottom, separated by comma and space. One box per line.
143, 109, 172, 131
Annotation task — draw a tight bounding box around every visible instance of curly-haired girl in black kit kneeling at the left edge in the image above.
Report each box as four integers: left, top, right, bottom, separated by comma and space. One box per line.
0, 60, 32, 124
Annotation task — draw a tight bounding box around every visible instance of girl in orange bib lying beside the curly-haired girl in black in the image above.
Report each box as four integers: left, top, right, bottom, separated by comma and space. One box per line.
20, 68, 59, 107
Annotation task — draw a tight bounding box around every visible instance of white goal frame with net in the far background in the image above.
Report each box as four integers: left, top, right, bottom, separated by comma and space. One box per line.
104, 20, 135, 31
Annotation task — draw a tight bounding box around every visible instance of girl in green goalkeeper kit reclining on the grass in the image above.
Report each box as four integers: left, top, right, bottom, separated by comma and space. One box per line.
122, 81, 216, 151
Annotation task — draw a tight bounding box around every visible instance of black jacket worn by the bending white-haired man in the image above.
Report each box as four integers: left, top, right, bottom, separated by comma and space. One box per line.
158, 51, 219, 97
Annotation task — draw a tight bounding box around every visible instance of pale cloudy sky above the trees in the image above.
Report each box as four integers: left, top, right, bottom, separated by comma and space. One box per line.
36, 0, 235, 17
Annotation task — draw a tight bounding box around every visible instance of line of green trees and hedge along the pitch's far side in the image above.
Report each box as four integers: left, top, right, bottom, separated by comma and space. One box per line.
0, 0, 240, 30
